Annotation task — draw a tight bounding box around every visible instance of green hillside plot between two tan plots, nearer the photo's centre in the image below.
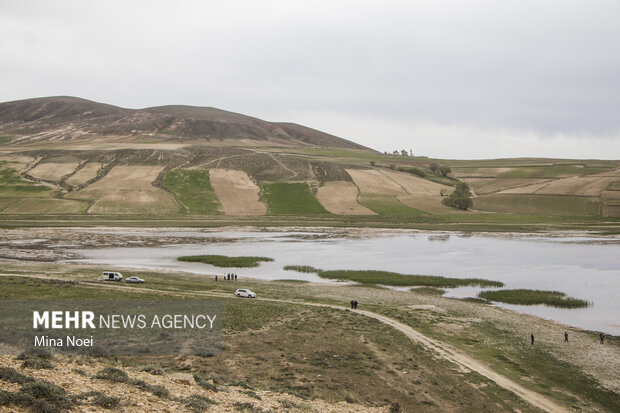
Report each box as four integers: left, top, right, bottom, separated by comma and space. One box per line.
261, 182, 329, 215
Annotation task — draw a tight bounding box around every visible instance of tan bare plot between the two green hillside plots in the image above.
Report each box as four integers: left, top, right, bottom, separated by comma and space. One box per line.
209, 169, 267, 215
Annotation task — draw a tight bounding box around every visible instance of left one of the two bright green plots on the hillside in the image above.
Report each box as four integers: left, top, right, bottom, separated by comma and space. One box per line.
163, 169, 223, 215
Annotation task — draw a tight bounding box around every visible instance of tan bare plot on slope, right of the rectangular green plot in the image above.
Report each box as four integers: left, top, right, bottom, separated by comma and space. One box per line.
317, 181, 376, 215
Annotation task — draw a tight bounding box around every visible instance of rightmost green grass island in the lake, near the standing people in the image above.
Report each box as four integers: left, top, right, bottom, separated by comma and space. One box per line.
478, 289, 588, 308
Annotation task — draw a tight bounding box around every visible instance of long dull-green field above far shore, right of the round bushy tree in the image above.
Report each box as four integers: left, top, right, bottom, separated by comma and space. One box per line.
473, 195, 601, 216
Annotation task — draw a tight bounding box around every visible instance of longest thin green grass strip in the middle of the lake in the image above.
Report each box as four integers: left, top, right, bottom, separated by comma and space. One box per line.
318, 270, 504, 288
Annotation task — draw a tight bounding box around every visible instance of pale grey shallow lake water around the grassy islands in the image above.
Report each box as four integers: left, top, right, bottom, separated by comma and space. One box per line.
65, 230, 620, 335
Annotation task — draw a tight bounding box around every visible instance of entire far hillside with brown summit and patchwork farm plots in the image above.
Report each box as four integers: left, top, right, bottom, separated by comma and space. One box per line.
0, 97, 620, 225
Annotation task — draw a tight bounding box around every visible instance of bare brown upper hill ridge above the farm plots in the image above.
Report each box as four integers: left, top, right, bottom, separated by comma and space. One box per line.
0, 96, 368, 149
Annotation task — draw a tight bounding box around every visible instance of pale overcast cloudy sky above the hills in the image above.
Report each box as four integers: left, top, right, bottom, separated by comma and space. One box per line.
0, 0, 620, 159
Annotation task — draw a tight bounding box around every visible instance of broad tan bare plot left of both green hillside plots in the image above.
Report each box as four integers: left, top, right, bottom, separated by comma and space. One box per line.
70, 166, 179, 214
